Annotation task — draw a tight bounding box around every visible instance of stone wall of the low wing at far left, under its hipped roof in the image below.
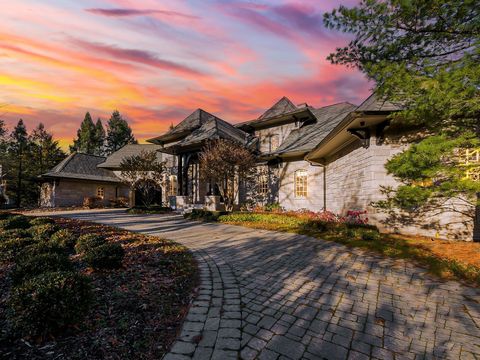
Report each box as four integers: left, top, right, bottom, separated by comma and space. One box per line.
40, 179, 129, 207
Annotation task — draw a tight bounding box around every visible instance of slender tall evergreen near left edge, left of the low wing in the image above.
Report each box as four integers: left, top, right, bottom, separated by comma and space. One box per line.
8, 119, 28, 207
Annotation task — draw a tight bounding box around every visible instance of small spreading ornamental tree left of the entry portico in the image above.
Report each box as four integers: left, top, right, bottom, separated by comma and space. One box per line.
120, 151, 165, 207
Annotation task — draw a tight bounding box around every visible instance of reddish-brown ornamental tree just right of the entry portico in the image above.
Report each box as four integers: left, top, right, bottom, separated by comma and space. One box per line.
199, 139, 255, 211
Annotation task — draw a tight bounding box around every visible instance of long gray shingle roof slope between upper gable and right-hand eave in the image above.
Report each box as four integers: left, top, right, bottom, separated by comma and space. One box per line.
271, 102, 356, 155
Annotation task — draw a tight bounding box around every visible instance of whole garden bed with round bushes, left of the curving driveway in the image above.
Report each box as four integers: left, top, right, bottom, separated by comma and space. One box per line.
0, 213, 196, 359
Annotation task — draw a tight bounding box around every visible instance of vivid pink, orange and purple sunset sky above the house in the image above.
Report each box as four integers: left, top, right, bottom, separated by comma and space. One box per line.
0, 0, 370, 146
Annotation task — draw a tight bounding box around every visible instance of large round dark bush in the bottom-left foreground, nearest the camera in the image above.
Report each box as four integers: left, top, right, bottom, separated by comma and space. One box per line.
8, 271, 92, 337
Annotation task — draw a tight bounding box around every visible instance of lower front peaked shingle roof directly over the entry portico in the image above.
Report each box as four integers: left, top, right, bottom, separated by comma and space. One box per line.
167, 117, 250, 150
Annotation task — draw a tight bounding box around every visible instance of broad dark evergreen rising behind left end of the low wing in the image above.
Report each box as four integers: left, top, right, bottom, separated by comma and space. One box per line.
29, 123, 66, 174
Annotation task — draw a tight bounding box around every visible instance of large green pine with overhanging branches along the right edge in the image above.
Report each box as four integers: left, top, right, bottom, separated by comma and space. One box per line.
324, 0, 480, 241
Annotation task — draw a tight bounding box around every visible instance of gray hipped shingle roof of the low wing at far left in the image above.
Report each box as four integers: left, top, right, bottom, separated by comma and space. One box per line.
40, 153, 120, 182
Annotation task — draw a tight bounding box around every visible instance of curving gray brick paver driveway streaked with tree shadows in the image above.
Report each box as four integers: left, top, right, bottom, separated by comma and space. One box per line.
42, 211, 480, 359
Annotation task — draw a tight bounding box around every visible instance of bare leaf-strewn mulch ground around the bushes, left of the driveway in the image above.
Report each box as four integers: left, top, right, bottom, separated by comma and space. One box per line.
0, 219, 197, 360
